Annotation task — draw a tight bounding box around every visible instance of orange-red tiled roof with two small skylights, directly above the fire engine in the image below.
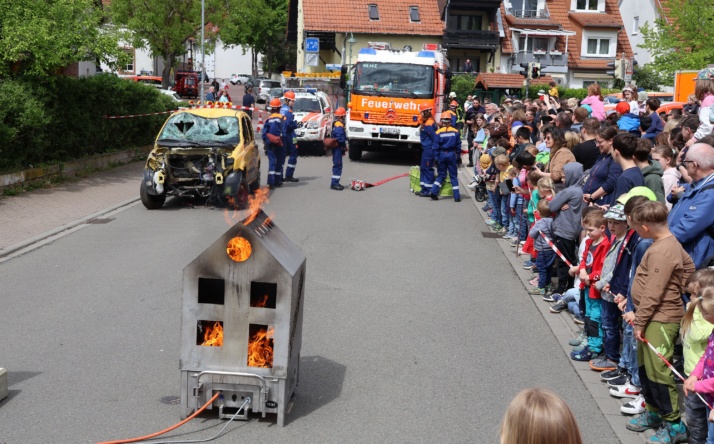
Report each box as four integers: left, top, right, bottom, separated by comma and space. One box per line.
302, 0, 444, 36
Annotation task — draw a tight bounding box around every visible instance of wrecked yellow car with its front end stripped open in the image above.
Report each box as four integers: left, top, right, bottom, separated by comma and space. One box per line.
140, 108, 260, 210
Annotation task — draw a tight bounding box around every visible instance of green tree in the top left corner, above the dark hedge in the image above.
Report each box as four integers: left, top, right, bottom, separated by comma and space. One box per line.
0, 0, 120, 77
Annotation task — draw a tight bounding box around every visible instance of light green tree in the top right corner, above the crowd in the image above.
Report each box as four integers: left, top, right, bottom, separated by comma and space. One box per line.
640, 0, 714, 84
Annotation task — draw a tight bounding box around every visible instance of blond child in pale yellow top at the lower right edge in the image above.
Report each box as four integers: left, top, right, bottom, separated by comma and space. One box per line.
682, 268, 714, 444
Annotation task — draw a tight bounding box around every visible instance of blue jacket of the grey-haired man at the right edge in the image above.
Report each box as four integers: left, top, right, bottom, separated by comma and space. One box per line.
667, 173, 714, 268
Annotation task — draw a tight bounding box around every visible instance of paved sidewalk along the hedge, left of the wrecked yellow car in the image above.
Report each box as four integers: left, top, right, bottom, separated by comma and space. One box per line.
0, 161, 144, 259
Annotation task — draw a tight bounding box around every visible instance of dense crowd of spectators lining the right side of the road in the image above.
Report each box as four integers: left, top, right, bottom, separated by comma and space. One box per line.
464, 68, 714, 443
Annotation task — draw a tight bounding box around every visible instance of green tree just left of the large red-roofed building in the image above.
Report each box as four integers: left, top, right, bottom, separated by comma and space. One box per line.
220, 0, 296, 74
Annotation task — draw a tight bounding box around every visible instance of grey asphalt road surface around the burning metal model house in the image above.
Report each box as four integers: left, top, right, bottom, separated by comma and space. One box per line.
0, 153, 618, 443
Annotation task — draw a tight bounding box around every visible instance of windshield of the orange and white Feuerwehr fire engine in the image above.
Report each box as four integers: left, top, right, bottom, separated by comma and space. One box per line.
353, 62, 434, 97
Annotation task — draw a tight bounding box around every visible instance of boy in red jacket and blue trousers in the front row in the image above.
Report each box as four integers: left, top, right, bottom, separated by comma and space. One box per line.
570, 210, 610, 361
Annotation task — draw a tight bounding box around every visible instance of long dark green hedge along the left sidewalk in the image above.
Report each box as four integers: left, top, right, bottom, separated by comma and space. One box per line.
0, 75, 176, 171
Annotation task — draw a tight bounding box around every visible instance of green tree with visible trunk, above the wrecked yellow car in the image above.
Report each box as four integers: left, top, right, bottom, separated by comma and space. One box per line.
110, 0, 221, 88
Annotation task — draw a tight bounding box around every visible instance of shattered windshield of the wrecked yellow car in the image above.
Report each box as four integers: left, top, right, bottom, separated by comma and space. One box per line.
158, 113, 240, 146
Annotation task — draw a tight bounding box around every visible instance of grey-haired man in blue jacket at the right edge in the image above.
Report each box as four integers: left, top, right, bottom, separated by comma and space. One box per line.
667, 143, 714, 268
